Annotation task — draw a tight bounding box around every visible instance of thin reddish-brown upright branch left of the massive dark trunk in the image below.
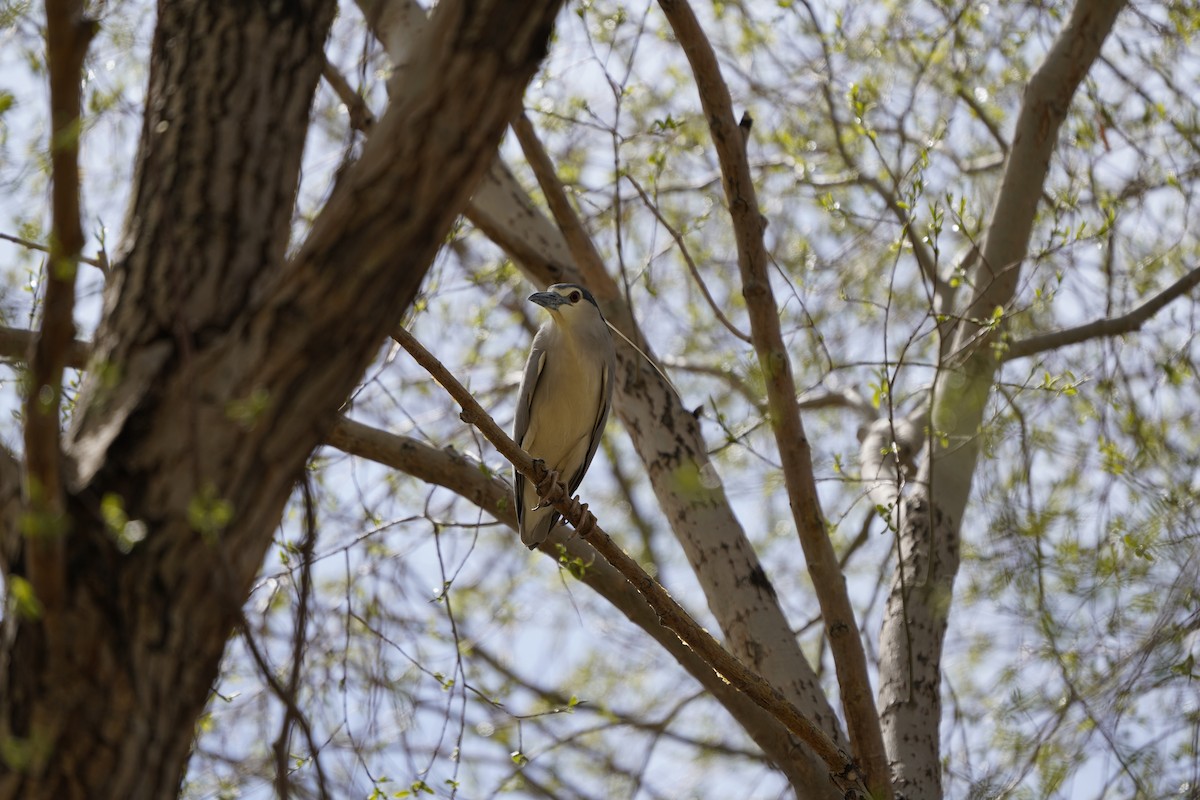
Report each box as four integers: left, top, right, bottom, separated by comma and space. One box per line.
22, 0, 96, 623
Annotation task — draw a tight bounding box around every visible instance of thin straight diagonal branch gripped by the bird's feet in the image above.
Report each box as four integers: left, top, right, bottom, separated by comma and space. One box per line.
394, 329, 872, 800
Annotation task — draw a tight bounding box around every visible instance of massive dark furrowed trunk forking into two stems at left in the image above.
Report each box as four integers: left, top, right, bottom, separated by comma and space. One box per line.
0, 0, 558, 800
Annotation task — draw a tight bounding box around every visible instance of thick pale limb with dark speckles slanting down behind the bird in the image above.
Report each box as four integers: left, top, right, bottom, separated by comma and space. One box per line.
359, 0, 844, 798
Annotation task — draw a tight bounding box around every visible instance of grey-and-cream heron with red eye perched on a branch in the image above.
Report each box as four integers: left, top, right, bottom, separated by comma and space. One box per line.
512, 283, 617, 549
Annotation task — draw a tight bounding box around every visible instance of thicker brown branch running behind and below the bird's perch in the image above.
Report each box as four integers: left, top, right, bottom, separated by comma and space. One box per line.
326, 417, 824, 786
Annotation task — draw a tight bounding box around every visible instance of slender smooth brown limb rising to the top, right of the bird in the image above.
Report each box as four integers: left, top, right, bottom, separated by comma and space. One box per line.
659, 0, 892, 799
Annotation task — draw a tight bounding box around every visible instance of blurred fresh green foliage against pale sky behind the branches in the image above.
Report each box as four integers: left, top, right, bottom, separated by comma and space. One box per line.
0, 0, 1200, 798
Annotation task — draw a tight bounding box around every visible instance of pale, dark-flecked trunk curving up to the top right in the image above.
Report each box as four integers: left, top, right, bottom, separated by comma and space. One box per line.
880, 0, 1124, 800
